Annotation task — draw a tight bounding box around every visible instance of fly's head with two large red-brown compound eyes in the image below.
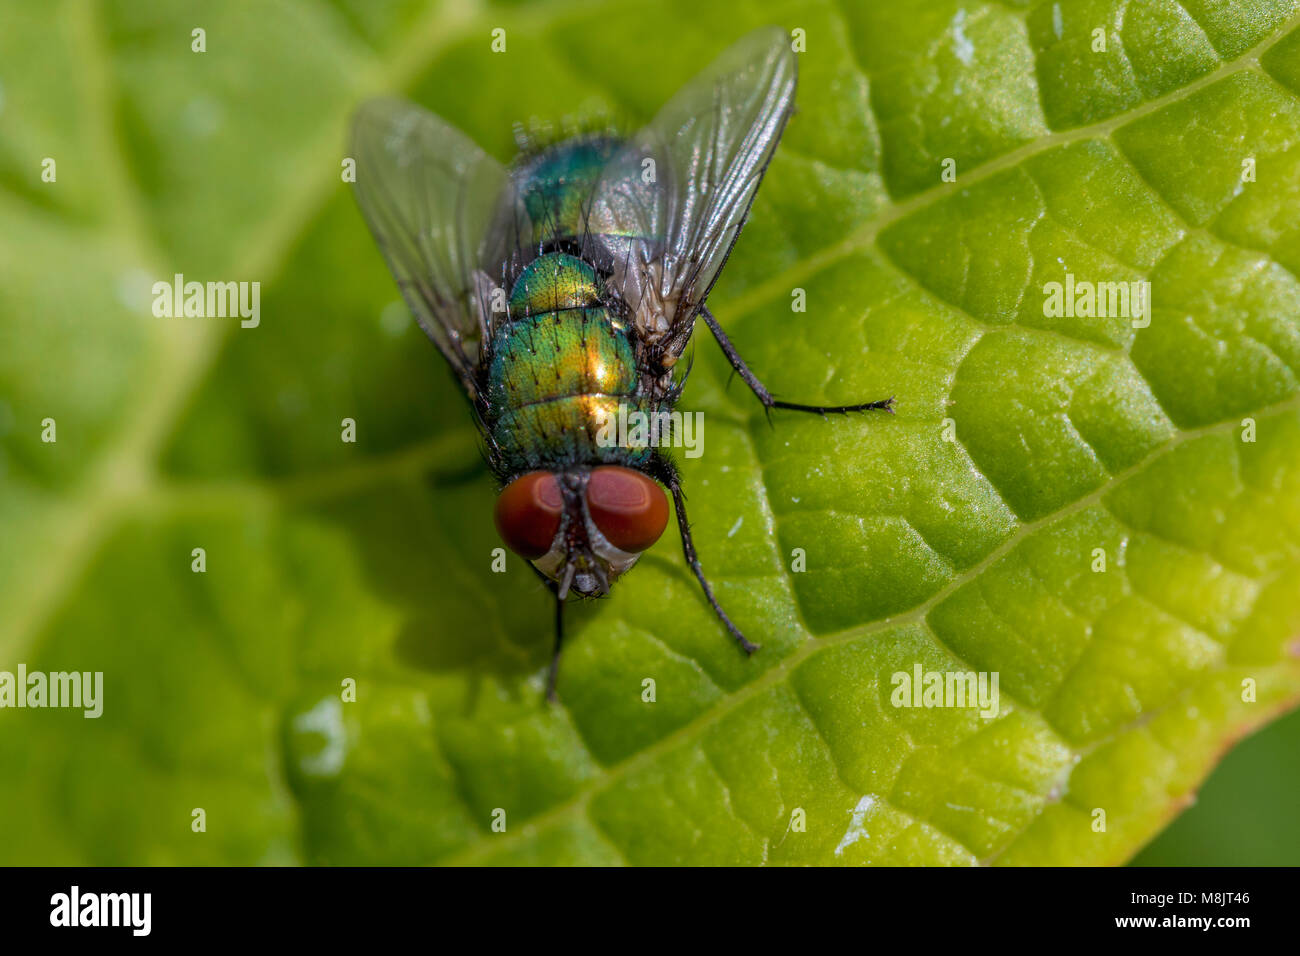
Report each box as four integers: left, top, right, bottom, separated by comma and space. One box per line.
497, 464, 668, 600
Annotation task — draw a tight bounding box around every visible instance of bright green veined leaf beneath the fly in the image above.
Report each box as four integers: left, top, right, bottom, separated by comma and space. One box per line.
0, 0, 1300, 865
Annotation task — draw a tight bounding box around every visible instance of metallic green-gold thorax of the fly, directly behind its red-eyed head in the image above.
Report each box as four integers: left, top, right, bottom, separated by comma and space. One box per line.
485, 254, 649, 472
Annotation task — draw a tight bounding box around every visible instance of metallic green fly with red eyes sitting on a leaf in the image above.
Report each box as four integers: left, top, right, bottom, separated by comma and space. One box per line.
352, 27, 893, 698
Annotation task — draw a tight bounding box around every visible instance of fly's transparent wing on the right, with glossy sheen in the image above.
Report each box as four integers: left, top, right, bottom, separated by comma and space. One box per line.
589, 27, 796, 358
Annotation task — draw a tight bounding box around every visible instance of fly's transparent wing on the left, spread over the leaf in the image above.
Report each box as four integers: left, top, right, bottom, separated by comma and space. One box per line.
352, 99, 507, 399
